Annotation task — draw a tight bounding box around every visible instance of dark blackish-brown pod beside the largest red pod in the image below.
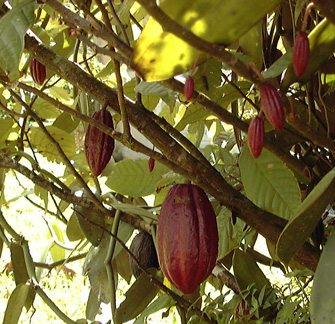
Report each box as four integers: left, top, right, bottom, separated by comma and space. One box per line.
129, 231, 159, 278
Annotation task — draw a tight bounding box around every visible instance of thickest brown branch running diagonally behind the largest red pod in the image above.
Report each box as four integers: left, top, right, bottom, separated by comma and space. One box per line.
26, 37, 318, 270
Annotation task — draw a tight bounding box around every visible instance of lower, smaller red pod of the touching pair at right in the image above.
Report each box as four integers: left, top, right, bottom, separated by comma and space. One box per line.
248, 117, 265, 158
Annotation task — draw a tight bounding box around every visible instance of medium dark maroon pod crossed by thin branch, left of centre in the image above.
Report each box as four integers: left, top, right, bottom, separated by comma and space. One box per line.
85, 109, 115, 177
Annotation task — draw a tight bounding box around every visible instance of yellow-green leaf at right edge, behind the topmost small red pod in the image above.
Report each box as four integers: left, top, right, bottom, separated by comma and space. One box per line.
281, 18, 335, 89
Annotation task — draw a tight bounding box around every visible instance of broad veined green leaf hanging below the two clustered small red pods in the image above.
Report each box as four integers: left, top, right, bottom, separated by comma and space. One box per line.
239, 145, 301, 219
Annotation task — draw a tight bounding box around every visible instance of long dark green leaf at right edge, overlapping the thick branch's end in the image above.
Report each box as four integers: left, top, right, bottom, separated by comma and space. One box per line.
277, 169, 335, 264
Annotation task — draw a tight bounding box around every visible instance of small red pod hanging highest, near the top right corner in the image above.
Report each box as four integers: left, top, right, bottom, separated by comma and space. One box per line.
292, 33, 310, 77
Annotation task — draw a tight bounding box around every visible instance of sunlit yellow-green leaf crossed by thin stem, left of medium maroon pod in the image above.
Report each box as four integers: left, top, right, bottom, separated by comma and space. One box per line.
30, 126, 76, 163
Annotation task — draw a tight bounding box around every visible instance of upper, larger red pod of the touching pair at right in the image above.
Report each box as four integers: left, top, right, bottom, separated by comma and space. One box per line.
259, 83, 285, 130
